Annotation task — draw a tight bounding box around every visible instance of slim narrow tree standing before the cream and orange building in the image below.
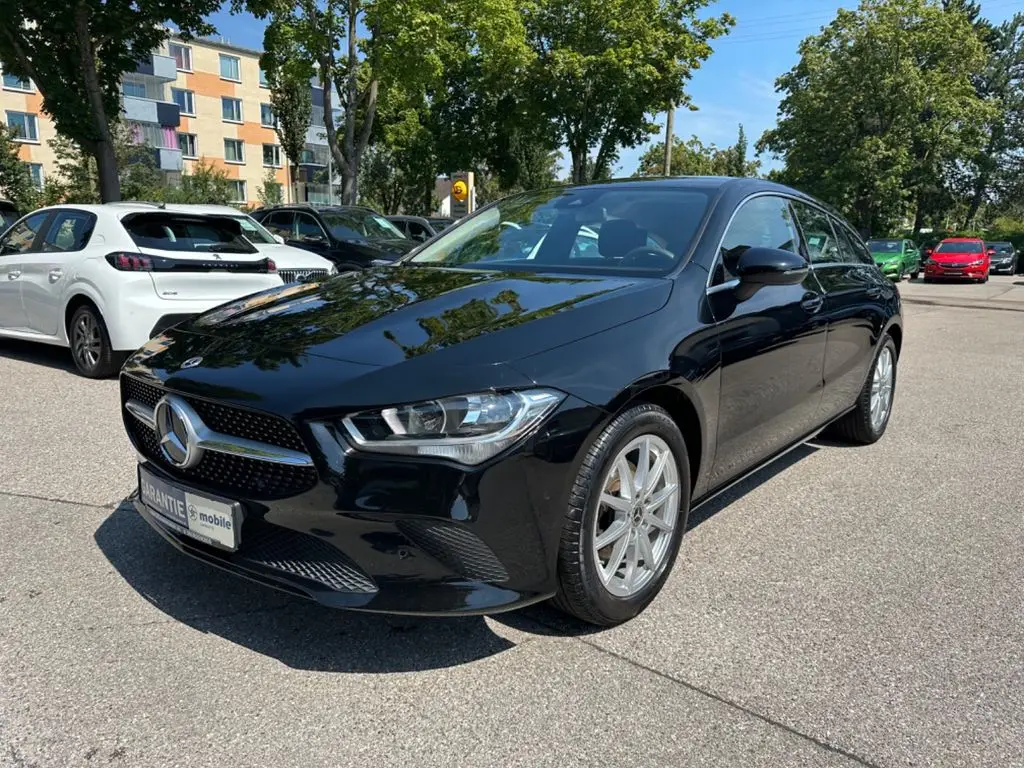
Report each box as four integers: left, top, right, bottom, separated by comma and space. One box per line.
260, 32, 311, 205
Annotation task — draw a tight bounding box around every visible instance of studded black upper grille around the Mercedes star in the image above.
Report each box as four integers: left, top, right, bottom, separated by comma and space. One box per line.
121, 376, 317, 500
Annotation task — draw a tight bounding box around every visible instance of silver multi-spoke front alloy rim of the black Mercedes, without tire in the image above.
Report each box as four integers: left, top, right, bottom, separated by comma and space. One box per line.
593, 434, 680, 597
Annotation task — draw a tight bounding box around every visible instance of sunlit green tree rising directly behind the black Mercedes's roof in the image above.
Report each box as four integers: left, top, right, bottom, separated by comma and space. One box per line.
522, 0, 733, 182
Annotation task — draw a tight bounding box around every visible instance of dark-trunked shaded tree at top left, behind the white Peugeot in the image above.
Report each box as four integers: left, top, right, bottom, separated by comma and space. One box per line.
0, 0, 220, 201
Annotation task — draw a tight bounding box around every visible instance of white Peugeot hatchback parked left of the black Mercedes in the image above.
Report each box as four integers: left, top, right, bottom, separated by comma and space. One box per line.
0, 203, 282, 378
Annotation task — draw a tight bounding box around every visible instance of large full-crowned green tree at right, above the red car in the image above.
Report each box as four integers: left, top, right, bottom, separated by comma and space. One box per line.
758, 0, 991, 232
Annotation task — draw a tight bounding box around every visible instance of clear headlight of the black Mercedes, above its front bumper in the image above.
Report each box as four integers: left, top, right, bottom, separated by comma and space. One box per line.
341, 389, 565, 464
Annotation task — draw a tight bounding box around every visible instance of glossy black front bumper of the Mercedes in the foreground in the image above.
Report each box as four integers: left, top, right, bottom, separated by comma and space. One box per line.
127, 399, 603, 615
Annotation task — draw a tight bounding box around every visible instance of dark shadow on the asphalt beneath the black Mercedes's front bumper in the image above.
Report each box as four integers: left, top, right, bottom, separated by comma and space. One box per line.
94, 503, 514, 674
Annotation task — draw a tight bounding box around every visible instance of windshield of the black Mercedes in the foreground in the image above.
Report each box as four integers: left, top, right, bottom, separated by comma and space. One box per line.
410, 187, 708, 274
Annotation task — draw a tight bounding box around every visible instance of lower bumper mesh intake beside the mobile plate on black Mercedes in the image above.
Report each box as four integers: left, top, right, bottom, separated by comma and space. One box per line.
237, 520, 377, 593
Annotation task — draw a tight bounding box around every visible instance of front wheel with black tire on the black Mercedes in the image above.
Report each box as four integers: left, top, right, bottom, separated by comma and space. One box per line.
554, 403, 690, 627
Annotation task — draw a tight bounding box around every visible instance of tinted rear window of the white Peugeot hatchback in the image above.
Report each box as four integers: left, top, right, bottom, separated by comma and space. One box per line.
121, 213, 257, 253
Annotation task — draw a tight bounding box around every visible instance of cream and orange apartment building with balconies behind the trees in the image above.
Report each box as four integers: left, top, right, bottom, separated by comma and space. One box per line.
0, 39, 330, 205
